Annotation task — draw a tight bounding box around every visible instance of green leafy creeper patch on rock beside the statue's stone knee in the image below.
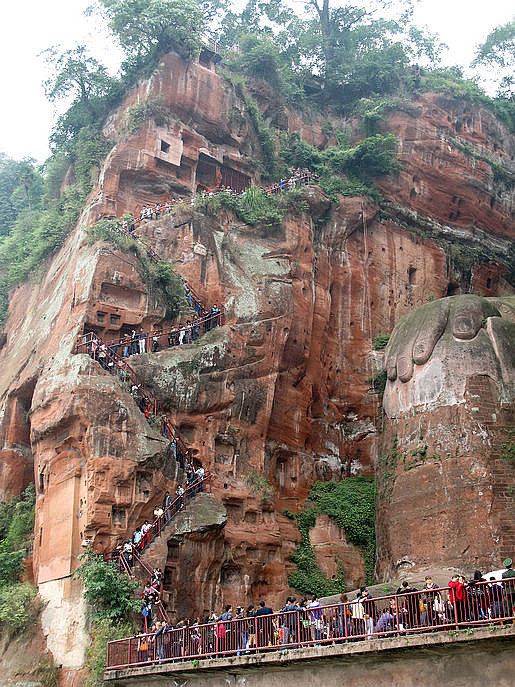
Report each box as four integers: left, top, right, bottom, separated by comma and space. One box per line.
287, 475, 375, 596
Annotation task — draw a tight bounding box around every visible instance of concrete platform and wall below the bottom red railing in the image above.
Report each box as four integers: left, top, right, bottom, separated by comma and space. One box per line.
104, 624, 515, 687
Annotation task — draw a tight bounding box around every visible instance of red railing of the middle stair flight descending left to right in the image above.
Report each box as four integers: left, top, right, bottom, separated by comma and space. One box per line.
76, 332, 190, 461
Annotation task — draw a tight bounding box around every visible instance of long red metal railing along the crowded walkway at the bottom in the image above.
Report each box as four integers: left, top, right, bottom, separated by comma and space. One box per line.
107, 580, 515, 670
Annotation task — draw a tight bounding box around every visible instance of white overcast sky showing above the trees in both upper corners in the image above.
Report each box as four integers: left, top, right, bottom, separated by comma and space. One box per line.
0, 0, 514, 162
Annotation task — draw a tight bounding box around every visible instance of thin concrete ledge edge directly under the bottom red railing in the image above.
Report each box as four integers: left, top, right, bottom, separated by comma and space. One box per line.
104, 625, 515, 684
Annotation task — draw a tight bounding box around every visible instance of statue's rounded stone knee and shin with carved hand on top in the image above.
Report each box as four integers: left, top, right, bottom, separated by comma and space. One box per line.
377, 296, 515, 577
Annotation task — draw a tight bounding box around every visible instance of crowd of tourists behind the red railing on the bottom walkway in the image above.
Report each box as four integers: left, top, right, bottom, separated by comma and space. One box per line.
106, 559, 515, 665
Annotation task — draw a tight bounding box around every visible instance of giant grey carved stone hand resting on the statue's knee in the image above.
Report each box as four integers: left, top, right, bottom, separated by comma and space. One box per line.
383, 295, 515, 417
